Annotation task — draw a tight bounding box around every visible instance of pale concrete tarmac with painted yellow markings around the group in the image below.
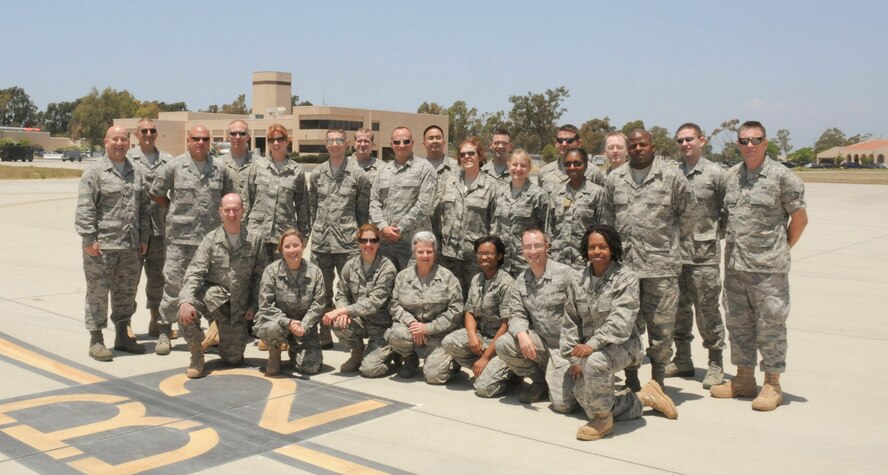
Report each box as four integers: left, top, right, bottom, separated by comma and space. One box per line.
0, 180, 888, 474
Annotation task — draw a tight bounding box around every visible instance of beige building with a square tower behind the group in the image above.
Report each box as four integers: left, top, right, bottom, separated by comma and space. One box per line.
114, 71, 449, 159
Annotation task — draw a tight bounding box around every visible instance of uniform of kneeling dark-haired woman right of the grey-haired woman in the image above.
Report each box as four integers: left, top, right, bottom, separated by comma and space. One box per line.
441, 269, 515, 397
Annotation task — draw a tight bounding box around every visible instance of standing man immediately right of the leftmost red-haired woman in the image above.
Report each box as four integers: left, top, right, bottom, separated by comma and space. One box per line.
308, 130, 370, 348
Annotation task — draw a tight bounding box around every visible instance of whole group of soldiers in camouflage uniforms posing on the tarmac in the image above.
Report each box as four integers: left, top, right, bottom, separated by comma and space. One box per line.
75, 119, 807, 439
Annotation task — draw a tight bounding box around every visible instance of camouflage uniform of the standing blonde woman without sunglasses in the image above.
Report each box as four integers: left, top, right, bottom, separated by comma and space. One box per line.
493, 180, 549, 277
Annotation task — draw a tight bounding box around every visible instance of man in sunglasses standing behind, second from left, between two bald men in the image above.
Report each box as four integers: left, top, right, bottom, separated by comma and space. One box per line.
126, 119, 173, 337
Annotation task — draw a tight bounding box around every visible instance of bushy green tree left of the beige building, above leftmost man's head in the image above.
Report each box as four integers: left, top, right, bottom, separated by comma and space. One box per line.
70, 87, 139, 148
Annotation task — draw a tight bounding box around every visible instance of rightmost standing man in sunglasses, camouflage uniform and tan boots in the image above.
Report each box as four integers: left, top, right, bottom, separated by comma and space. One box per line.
709, 121, 808, 411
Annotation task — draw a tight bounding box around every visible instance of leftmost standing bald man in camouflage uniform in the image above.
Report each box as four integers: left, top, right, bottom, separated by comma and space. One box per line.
74, 126, 151, 361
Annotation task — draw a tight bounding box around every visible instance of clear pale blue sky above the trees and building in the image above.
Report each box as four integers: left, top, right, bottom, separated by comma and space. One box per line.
0, 0, 888, 149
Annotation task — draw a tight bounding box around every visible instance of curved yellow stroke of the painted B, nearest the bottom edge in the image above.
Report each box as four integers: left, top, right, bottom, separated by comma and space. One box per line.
68, 426, 219, 474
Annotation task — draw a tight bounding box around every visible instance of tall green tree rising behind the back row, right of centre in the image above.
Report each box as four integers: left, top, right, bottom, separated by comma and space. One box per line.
509, 86, 570, 153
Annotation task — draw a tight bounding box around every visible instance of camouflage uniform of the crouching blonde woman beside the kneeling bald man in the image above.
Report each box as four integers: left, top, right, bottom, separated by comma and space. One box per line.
253, 259, 324, 374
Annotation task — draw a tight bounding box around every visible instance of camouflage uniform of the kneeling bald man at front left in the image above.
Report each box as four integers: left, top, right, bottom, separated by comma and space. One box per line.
179, 226, 265, 365
